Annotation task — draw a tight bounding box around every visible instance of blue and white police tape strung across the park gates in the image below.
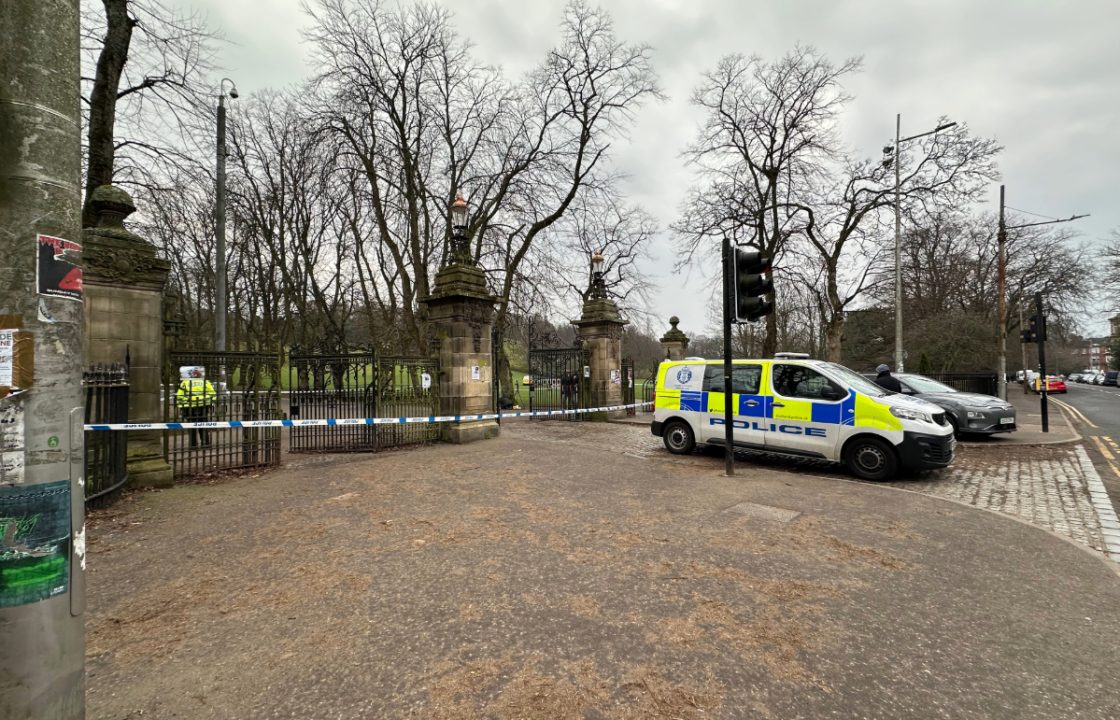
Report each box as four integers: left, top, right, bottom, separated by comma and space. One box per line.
85, 402, 653, 431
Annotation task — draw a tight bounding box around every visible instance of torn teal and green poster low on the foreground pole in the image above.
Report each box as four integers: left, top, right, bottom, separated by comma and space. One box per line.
0, 480, 71, 608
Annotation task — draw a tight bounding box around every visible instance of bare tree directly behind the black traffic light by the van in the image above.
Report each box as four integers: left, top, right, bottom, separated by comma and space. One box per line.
673, 47, 860, 354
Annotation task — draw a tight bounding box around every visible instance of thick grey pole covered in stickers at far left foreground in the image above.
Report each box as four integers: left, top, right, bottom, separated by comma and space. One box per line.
0, 0, 85, 720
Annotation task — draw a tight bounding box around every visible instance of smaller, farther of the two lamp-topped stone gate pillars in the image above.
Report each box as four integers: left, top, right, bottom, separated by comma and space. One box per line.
571, 253, 627, 420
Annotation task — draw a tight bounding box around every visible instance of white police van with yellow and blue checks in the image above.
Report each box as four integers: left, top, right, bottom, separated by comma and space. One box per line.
652, 353, 956, 480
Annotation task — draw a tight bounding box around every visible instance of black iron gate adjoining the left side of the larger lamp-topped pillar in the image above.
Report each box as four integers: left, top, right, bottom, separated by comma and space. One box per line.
288, 352, 439, 452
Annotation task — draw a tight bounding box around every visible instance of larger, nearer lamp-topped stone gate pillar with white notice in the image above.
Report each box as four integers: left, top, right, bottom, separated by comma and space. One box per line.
421, 211, 498, 443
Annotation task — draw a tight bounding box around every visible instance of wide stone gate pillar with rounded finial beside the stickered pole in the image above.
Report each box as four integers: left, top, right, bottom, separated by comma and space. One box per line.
82, 185, 172, 486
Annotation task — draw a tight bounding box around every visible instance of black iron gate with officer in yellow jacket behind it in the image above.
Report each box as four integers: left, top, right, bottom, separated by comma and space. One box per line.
164, 350, 281, 477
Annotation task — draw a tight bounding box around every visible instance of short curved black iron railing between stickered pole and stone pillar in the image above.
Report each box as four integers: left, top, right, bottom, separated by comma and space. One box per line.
82, 363, 129, 507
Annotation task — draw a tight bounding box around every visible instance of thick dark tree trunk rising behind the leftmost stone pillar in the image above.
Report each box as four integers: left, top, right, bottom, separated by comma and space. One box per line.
82, 0, 136, 227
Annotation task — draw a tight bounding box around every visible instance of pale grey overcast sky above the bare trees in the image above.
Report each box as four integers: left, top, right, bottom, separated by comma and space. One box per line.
179, 0, 1120, 335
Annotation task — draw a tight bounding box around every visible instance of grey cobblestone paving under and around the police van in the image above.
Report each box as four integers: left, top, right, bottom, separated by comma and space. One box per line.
503, 422, 1108, 554
